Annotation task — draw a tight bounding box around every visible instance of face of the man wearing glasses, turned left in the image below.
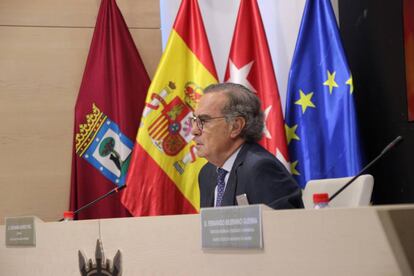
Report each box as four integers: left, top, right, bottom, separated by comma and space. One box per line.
191, 92, 233, 166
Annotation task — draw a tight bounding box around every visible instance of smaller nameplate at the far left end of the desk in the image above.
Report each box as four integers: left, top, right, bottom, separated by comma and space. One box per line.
6, 217, 36, 247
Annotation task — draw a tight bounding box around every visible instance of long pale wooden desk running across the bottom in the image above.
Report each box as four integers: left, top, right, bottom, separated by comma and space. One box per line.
0, 205, 414, 276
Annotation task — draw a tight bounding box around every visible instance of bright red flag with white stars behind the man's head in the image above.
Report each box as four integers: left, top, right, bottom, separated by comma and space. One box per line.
224, 0, 289, 167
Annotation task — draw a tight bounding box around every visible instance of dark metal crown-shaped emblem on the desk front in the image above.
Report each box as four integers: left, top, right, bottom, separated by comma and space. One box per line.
78, 239, 122, 276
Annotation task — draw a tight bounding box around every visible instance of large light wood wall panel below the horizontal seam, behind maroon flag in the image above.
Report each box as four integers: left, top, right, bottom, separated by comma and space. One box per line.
0, 27, 161, 223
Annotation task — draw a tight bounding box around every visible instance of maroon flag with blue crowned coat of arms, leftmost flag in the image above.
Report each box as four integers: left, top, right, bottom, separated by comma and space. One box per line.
70, 0, 150, 219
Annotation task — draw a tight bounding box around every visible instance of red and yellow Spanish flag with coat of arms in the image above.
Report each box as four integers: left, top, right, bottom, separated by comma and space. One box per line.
122, 0, 217, 216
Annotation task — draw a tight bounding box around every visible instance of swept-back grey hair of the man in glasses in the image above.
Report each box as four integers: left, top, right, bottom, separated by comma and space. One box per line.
204, 82, 264, 142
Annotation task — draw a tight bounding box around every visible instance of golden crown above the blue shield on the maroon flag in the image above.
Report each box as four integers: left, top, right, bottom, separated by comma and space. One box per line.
75, 103, 107, 156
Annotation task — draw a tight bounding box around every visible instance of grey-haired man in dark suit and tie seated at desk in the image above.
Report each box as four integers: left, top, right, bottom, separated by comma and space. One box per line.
192, 83, 303, 209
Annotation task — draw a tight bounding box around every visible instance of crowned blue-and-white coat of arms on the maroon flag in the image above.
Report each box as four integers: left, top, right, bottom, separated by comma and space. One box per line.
75, 104, 134, 186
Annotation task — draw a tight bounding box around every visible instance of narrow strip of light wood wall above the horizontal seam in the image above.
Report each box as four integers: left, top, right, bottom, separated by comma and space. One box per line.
0, 0, 160, 29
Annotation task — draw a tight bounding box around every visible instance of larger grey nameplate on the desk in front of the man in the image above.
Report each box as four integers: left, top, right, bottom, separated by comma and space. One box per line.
200, 205, 268, 249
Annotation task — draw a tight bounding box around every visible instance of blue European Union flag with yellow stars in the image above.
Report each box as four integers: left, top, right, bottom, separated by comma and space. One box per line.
285, 0, 362, 187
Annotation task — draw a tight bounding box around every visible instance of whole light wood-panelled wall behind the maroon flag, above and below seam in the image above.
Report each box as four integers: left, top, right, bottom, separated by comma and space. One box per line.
0, 0, 161, 223
